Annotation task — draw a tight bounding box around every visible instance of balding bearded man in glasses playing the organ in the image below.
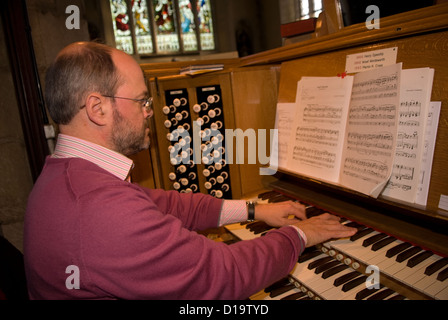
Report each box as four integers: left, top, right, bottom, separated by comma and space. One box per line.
24, 43, 355, 299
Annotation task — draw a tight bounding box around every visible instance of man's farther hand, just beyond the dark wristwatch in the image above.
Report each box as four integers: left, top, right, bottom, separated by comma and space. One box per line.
255, 201, 306, 227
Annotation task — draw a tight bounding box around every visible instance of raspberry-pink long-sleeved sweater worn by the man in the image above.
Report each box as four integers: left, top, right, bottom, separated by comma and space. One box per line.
24, 158, 304, 299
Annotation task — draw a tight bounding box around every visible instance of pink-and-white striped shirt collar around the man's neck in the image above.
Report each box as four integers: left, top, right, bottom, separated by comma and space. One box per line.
52, 134, 133, 180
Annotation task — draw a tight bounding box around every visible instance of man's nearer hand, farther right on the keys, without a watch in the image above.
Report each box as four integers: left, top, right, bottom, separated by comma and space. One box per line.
294, 213, 357, 247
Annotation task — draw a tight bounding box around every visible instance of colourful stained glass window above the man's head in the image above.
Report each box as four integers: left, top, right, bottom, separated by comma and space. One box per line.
109, 0, 215, 56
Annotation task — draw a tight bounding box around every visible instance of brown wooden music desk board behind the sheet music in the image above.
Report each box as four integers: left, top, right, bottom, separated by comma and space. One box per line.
279, 31, 448, 219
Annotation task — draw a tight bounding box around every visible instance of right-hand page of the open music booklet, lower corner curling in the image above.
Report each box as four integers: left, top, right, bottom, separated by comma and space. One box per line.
340, 63, 401, 197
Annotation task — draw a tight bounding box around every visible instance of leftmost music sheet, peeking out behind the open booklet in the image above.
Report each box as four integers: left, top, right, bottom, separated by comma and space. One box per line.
270, 103, 296, 169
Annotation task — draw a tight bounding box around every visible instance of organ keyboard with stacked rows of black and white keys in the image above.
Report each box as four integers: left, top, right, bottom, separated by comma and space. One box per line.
227, 191, 448, 300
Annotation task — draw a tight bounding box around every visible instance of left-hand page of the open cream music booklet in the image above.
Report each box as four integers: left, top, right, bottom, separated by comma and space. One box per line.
287, 76, 353, 182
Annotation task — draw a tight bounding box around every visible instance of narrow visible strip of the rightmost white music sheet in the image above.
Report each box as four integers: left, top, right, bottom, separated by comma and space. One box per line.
415, 101, 442, 206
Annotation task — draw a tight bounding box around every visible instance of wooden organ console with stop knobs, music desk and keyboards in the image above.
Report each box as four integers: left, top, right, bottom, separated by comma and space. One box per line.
133, 3, 448, 300
